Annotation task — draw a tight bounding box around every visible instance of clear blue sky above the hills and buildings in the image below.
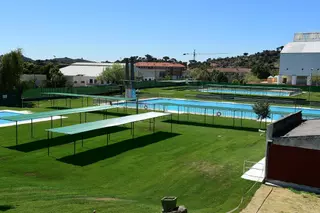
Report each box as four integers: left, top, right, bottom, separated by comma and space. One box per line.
0, 0, 320, 61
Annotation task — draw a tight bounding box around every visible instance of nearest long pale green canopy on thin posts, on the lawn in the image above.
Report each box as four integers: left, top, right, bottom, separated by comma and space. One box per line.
46, 112, 172, 155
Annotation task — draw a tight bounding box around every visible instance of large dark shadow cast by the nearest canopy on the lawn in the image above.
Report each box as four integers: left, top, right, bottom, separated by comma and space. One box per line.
58, 132, 179, 166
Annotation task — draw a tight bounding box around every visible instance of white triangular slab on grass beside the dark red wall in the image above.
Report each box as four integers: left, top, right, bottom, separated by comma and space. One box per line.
241, 157, 266, 183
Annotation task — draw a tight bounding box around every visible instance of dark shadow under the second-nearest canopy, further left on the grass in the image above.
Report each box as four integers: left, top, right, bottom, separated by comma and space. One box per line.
7, 127, 129, 152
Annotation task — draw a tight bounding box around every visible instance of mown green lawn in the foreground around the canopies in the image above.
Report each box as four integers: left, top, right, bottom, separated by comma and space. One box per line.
0, 100, 265, 213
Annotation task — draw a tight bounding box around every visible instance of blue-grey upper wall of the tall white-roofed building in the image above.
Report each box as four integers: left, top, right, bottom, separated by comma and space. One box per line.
280, 53, 320, 76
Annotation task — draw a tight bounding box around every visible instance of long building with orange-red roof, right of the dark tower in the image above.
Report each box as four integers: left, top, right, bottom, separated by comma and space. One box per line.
135, 62, 186, 81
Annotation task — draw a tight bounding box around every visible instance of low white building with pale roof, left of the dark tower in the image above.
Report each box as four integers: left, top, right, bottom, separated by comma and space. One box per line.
60, 62, 125, 86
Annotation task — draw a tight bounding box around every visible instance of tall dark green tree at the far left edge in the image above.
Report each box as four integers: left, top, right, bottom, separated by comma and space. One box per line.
0, 49, 24, 92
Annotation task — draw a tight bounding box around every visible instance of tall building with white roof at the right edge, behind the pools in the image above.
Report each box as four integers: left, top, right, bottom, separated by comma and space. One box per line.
278, 33, 320, 85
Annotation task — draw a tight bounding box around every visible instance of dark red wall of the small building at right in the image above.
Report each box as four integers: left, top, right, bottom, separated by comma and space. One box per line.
267, 144, 320, 188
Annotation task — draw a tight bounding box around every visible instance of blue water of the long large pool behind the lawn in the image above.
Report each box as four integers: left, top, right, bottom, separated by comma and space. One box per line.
122, 98, 320, 120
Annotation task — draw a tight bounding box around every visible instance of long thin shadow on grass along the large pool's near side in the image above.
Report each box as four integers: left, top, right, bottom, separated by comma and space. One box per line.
163, 120, 259, 132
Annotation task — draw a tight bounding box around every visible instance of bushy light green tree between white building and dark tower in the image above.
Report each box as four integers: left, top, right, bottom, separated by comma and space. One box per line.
98, 64, 125, 84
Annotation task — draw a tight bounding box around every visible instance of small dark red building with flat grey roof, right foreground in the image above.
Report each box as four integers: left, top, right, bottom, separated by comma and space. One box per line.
265, 111, 320, 191
